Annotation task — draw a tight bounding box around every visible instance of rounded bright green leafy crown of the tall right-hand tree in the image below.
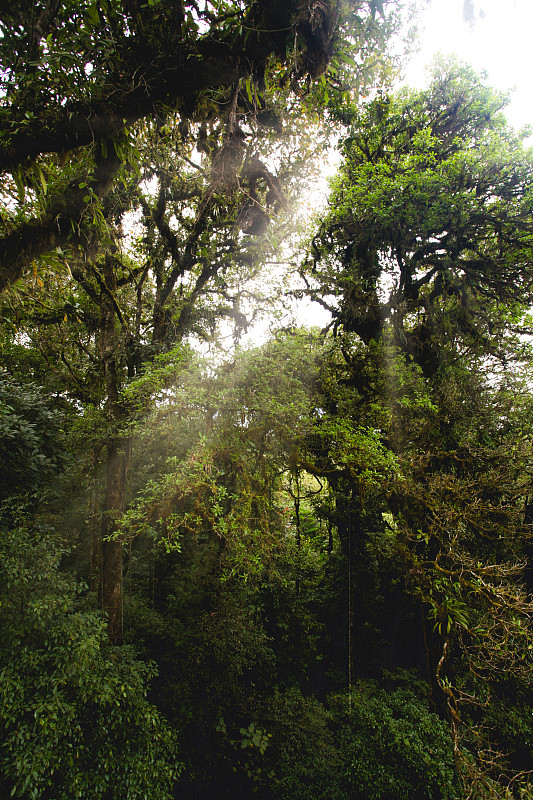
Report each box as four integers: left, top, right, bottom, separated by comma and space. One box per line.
309, 57, 532, 354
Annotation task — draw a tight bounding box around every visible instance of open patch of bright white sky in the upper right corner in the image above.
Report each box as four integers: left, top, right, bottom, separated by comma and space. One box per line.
406, 0, 533, 127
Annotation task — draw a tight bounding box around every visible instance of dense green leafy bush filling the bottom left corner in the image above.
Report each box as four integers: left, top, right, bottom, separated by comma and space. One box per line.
0, 528, 179, 800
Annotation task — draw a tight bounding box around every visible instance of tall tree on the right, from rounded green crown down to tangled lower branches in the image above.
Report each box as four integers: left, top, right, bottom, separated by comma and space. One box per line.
304, 59, 533, 796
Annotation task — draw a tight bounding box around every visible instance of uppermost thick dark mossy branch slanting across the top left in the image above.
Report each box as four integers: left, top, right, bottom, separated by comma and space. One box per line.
0, 0, 332, 170
